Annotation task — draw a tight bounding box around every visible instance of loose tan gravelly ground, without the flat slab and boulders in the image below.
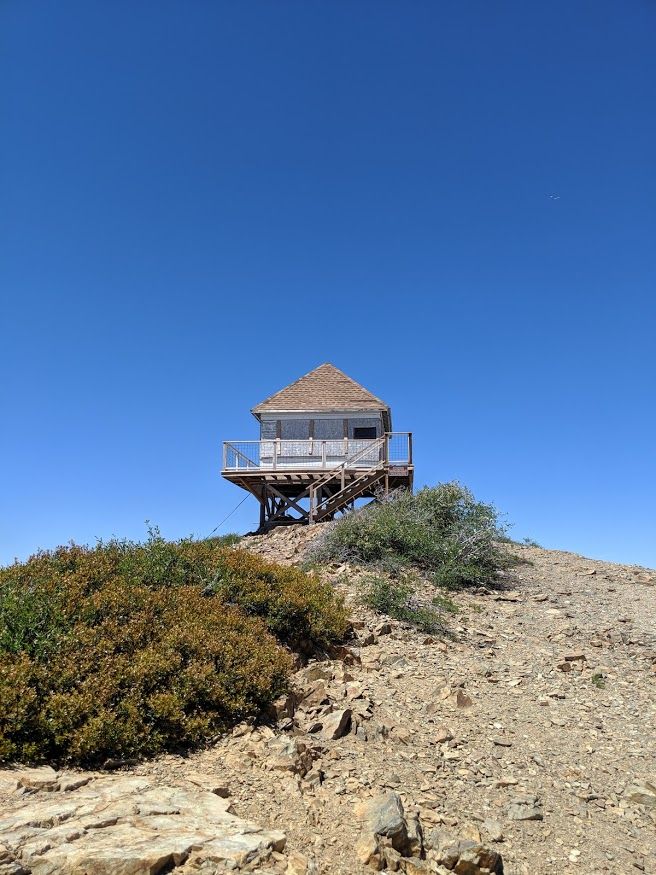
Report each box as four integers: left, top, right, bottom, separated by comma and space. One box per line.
131, 530, 656, 875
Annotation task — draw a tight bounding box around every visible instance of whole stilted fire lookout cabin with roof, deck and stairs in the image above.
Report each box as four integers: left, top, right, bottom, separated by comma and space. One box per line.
221, 364, 414, 531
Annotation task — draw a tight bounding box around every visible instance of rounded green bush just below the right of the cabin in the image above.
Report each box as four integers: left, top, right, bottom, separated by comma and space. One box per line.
314, 483, 505, 588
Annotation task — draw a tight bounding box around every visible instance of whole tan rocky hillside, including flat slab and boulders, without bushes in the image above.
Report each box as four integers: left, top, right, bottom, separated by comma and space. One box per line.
0, 529, 656, 875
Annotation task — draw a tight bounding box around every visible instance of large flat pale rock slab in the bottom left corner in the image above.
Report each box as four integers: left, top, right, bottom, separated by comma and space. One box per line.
0, 775, 285, 875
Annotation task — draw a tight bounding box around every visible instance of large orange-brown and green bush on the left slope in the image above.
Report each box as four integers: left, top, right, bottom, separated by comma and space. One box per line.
0, 531, 346, 765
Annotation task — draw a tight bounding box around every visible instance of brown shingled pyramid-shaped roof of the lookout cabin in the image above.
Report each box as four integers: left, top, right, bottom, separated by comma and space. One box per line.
253, 363, 389, 417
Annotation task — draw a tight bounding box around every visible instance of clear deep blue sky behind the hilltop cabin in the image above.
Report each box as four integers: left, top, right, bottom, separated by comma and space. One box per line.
0, 0, 656, 566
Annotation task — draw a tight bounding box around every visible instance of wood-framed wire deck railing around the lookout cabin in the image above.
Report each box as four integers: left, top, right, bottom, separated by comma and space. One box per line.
222, 431, 412, 473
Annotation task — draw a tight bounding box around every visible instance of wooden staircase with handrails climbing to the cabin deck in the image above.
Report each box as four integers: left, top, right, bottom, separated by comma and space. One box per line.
309, 435, 387, 525
